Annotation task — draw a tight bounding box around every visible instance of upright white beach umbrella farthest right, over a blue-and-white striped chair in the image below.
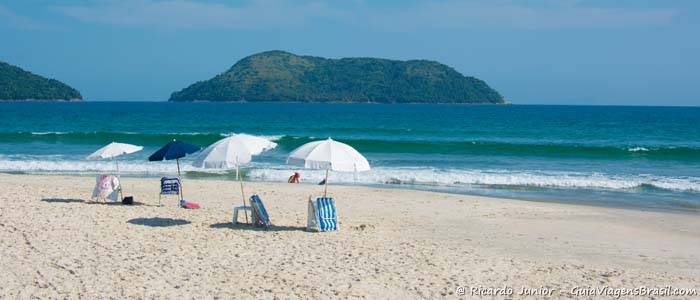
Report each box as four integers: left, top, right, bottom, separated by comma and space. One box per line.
287, 138, 370, 196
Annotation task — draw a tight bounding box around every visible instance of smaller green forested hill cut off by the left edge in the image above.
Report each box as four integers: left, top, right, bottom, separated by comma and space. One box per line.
0, 61, 83, 101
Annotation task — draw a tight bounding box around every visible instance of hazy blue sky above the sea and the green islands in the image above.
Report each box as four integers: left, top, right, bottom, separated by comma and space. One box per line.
0, 0, 700, 106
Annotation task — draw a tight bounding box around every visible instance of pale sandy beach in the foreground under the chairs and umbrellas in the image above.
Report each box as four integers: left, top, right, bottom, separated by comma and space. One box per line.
0, 174, 700, 299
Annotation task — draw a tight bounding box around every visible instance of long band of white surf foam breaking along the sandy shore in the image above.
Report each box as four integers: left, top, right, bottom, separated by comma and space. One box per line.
0, 155, 700, 192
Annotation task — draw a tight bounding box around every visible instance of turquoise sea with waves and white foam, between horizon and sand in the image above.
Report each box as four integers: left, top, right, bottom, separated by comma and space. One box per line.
0, 102, 700, 211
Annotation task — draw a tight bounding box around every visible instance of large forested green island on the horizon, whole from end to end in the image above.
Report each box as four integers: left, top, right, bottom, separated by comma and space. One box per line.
168, 51, 506, 104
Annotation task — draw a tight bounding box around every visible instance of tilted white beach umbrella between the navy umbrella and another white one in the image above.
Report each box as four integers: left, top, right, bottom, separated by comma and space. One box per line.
193, 134, 277, 222
